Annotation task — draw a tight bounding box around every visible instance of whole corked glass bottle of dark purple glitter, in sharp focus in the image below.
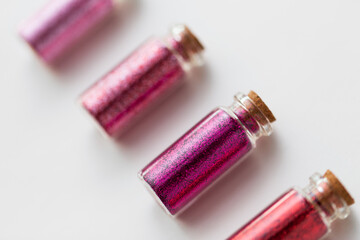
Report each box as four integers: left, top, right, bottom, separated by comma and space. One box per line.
139, 91, 275, 215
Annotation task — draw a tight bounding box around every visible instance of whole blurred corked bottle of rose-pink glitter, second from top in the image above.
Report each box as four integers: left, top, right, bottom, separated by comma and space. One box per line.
80, 25, 204, 136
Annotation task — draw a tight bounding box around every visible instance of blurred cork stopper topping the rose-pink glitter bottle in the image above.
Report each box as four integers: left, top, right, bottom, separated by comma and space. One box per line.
172, 24, 204, 60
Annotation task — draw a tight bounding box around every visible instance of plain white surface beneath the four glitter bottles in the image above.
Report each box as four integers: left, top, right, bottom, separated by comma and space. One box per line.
0, 0, 360, 240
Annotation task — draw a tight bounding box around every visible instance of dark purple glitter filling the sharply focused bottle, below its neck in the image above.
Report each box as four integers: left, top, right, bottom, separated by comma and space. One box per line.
140, 108, 254, 215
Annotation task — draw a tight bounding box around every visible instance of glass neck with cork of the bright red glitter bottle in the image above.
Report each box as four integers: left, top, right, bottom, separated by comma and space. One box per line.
303, 171, 354, 227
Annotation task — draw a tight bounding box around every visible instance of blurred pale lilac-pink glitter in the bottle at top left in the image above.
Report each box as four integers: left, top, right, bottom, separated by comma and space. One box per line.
20, 0, 114, 63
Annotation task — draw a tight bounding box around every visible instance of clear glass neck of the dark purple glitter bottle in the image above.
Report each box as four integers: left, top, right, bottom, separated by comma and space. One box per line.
228, 93, 272, 142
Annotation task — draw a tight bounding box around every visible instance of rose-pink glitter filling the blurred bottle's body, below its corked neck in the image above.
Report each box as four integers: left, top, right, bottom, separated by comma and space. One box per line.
81, 39, 185, 136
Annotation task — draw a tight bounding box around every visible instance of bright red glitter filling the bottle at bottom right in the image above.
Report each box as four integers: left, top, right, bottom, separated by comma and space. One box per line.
229, 189, 328, 240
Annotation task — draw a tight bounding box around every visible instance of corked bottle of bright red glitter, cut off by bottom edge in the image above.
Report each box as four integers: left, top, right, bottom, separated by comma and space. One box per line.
228, 170, 354, 240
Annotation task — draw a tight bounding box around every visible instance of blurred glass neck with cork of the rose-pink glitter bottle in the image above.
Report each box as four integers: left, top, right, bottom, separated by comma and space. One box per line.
164, 24, 204, 70
